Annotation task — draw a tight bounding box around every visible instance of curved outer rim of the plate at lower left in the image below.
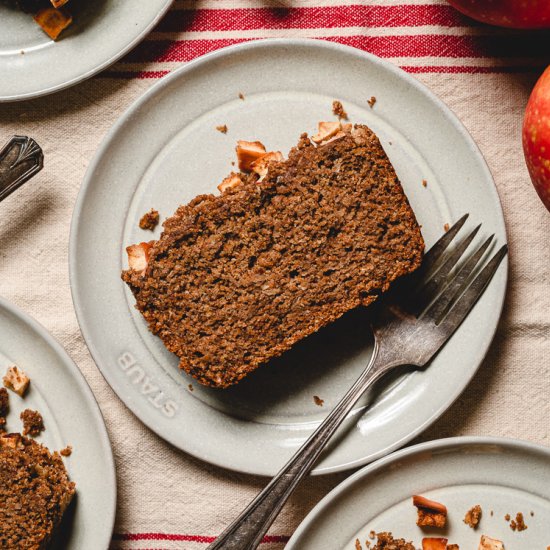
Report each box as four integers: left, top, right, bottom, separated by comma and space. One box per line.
0, 297, 118, 548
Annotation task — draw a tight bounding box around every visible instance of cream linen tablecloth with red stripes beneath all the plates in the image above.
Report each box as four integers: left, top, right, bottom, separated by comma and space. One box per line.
0, 0, 550, 550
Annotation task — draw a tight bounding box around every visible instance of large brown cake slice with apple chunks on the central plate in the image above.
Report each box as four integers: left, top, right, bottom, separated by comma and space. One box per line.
122, 123, 424, 388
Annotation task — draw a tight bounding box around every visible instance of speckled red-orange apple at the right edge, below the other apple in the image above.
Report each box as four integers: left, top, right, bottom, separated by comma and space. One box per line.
523, 67, 550, 211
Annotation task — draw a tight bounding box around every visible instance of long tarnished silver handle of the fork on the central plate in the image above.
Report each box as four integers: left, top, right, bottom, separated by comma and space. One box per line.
207, 341, 385, 550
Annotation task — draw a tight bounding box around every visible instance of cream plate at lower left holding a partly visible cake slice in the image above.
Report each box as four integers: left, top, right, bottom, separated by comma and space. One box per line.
0, 299, 116, 550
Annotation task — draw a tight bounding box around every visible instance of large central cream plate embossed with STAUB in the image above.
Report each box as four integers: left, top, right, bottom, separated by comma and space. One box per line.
70, 40, 507, 475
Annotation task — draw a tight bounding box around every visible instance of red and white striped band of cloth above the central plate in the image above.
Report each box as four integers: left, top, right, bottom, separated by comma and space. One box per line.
107, 0, 550, 78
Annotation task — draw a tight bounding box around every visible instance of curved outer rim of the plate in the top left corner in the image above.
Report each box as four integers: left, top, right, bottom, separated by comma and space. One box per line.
0, 0, 174, 104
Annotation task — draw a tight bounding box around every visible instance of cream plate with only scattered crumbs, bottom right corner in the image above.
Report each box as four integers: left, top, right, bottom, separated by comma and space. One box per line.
286, 437, 550, 550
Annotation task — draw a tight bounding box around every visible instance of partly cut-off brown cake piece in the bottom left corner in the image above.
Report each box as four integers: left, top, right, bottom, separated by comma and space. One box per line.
0, 434, 75, 550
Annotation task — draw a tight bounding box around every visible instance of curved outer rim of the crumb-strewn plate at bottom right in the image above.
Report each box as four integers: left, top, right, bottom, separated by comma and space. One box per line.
285, 435, 550, 550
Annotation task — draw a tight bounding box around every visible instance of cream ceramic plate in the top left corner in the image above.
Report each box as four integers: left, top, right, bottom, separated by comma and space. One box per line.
0, 0, 172, 102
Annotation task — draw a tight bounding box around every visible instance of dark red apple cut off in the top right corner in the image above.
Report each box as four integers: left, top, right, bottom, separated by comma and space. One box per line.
449, 0, 550, 29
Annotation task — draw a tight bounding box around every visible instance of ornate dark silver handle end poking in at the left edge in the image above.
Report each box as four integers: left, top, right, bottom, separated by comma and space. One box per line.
0, 136, 44, 201
